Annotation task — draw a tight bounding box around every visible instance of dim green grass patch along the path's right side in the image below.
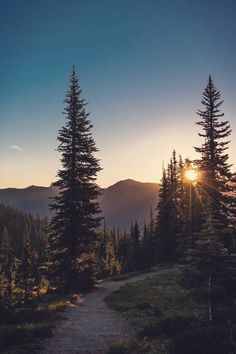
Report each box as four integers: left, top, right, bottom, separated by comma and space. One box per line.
106, 270, 205, 354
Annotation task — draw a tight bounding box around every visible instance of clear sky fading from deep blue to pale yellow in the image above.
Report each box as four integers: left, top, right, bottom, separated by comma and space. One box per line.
0, 0, 236, 188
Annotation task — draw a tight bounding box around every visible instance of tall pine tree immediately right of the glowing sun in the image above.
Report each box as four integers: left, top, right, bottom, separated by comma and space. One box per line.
195, 76, 232, 243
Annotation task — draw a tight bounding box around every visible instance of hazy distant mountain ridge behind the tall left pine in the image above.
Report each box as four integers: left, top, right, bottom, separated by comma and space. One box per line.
0, 179, 159, 230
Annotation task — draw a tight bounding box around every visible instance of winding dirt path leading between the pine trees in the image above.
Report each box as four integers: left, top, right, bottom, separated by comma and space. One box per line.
41, 272, 162, 354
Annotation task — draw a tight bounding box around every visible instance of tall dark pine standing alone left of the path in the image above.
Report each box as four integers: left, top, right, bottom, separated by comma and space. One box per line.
50, 68, 101, 290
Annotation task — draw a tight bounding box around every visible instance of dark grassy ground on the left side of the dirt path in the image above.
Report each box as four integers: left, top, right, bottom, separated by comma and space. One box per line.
0, 294, 79, 354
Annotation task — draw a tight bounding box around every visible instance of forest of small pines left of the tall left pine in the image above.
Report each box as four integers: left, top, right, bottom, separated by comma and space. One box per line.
0, 204, 48, 310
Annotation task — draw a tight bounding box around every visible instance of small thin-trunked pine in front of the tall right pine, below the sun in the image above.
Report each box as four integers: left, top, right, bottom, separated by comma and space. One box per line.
186, 206, 227, 324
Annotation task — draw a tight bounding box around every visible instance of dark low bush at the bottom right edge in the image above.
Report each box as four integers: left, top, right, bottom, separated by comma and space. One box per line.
170, 327, 231, 354
